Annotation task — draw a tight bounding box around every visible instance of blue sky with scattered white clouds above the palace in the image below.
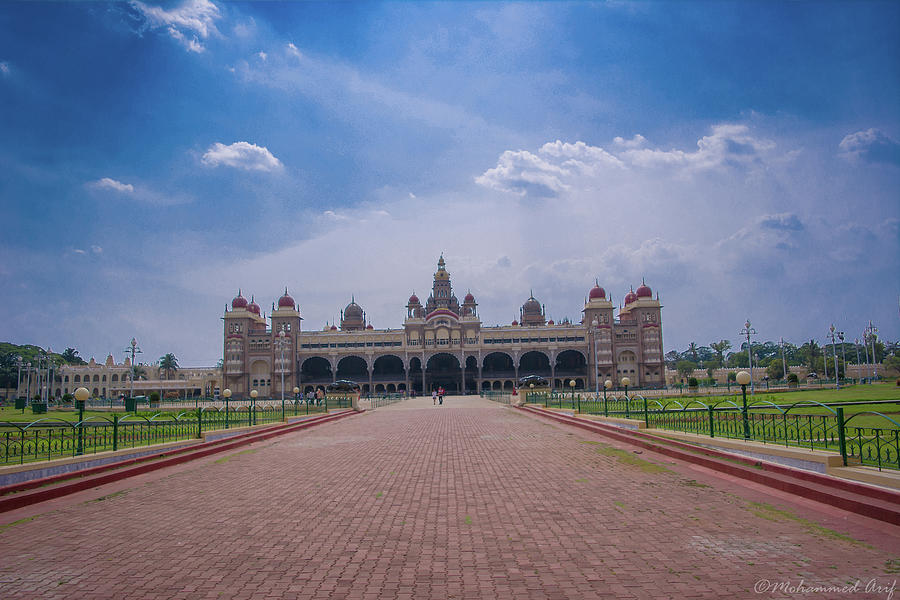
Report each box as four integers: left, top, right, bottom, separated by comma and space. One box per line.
0, 0, 900, 366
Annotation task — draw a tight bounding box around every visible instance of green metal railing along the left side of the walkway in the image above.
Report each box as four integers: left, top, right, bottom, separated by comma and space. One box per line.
0, 396, 351, 464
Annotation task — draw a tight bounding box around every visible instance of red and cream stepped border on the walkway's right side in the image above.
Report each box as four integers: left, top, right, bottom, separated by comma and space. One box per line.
516, 406, 900, 525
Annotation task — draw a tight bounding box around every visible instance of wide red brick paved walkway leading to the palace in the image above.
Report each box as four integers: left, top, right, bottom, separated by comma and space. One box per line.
0, 397, 900, 599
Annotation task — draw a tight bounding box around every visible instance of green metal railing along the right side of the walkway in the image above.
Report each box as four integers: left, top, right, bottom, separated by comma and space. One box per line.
527, 392, 900, 469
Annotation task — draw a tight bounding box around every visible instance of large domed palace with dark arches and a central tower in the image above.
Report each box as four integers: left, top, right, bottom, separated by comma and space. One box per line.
222, 256, 665, 398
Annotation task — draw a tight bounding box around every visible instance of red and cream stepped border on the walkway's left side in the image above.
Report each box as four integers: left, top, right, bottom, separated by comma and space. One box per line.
0, 410, 363, 513
